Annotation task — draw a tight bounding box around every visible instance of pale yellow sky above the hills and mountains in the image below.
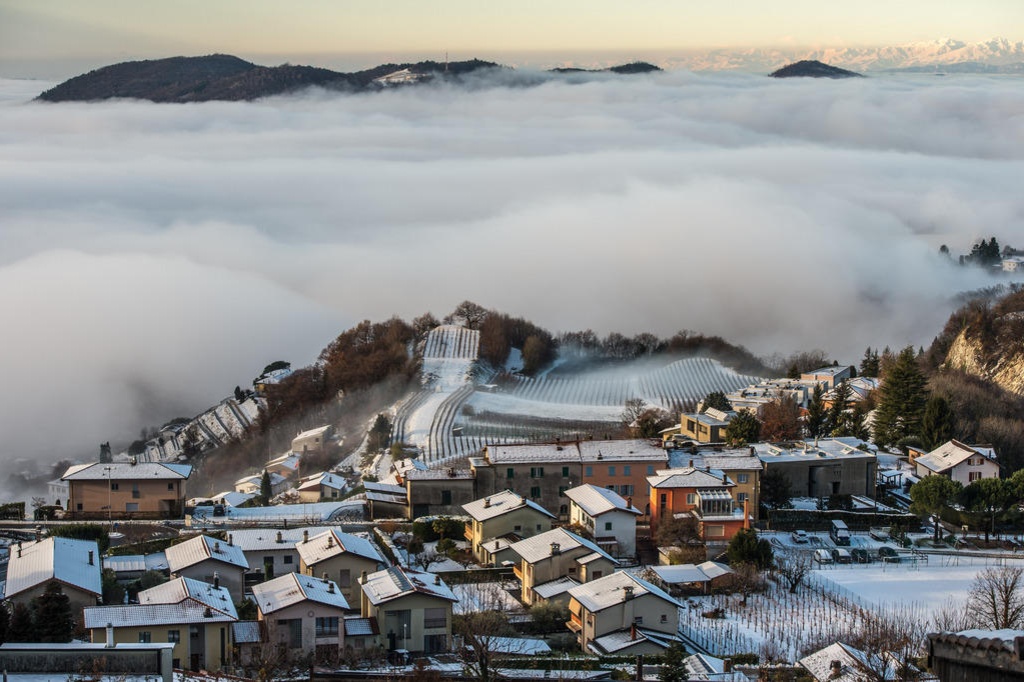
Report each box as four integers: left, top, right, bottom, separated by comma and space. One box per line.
0, 0, 1024, 74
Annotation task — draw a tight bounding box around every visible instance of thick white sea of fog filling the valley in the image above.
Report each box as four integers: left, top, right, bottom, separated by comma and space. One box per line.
0, 67, 1024, 459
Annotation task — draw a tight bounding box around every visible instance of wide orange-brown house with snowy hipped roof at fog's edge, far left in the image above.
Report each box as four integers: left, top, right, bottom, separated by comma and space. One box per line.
60, 459, 191, 519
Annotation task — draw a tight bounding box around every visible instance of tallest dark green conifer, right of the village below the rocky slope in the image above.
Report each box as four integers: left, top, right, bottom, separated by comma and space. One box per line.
874, 346, 928, 446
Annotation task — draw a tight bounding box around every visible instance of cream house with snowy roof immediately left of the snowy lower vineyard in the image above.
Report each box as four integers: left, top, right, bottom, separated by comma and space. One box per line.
565, 571, 681, 655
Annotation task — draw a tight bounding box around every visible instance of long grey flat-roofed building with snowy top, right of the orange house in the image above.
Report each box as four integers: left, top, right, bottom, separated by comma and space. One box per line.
752, 437, 878, 500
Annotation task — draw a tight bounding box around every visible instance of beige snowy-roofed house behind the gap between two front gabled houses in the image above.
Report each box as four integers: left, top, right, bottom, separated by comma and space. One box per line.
295, 528, 385, 604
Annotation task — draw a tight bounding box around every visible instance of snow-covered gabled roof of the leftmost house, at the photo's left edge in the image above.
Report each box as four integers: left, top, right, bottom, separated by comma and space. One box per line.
4, 538, 102, 599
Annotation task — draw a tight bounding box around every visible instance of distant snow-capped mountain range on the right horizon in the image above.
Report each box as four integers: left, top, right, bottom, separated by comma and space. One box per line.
662, 38, 1024, 72
